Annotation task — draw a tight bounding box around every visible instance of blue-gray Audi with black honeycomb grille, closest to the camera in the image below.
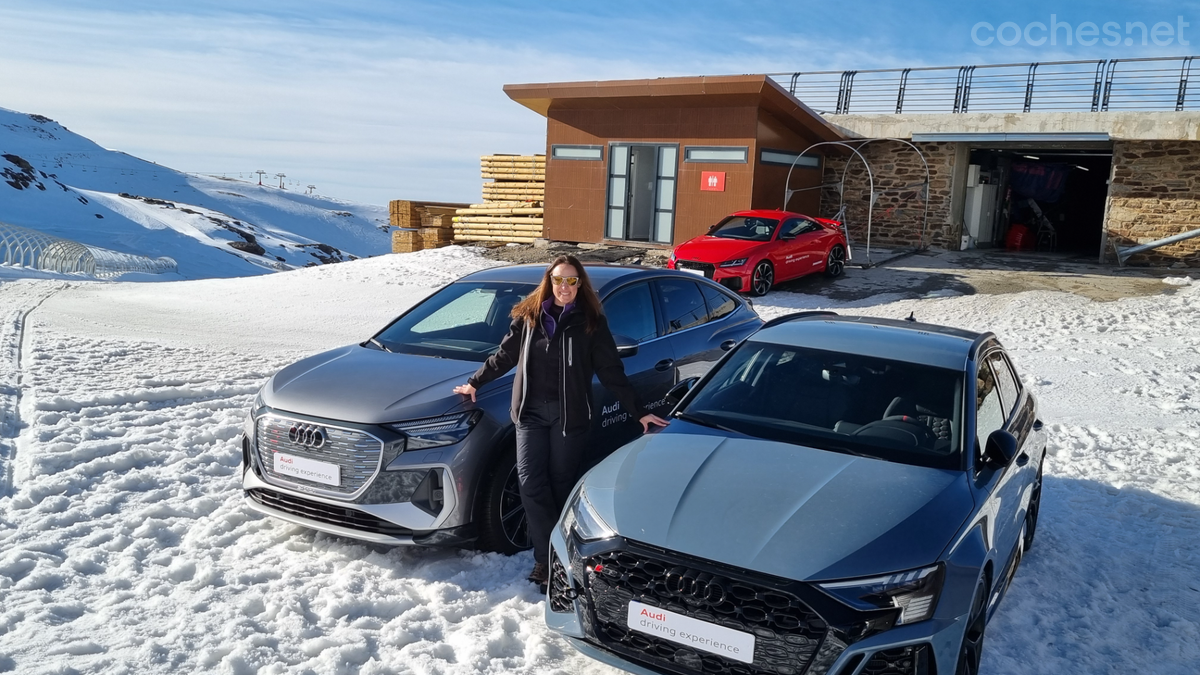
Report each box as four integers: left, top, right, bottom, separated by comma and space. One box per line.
546, 312, 1046, 675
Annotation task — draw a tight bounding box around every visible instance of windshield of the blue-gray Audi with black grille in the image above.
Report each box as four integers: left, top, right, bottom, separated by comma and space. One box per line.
682, 341, 962, 468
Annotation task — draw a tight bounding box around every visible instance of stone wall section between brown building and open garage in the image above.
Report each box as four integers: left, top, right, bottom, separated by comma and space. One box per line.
821, 141, 961, 251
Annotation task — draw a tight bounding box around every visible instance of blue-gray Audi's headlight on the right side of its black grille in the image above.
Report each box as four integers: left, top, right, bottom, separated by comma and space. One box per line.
817, 563, 946, 626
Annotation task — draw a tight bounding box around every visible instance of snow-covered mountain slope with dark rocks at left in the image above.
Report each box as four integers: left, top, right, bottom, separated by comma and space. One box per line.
0, 108, 390, 279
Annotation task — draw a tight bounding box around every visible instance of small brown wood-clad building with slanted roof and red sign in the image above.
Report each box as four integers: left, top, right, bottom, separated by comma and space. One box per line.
504, 76, 845, 245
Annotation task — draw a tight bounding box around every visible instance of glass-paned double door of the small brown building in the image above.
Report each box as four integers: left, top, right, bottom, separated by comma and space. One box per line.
605, 143, 679, 244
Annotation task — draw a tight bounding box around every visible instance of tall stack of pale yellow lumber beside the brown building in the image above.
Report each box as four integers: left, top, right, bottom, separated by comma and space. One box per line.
454, 155, 546, 243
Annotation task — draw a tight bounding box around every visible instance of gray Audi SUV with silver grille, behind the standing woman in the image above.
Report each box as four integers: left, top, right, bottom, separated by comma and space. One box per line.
241, 265, 762, 552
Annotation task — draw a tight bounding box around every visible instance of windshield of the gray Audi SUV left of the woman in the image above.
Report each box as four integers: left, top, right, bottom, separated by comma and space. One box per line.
373, 282, 536, 362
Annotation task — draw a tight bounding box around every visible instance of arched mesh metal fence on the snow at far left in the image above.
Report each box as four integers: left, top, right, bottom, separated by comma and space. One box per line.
0, 222, 178, 279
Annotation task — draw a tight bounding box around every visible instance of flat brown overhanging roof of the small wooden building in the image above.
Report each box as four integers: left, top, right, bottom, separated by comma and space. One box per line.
504, 74, 848, 141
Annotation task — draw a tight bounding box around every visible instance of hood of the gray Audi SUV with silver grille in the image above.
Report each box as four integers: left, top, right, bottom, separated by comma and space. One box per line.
263, 345, 479, 424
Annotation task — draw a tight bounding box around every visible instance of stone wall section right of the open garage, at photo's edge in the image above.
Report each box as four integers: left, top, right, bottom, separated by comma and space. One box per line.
1104, 141, 1200, 267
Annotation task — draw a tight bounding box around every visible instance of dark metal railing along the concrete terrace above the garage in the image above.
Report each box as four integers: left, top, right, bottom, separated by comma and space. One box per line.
768, 56, 1200, 115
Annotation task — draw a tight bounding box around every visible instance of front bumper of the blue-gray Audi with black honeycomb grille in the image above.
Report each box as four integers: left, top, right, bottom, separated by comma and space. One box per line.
546, 528, 966, 675
